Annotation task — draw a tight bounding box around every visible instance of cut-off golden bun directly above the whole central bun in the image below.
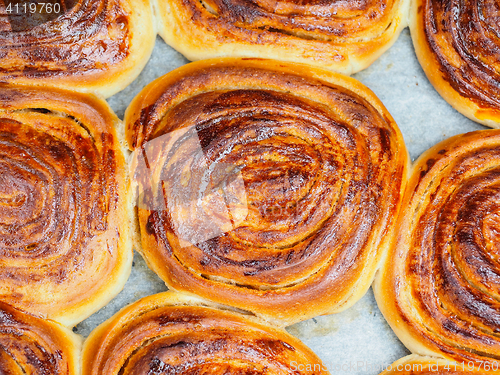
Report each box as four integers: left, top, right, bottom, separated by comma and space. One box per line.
156, 0, 409, 74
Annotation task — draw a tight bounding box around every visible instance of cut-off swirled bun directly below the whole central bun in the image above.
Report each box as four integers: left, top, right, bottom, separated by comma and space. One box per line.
83, 292, 328, 375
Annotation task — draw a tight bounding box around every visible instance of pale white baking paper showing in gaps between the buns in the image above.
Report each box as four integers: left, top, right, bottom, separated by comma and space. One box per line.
75, 29, 484, 375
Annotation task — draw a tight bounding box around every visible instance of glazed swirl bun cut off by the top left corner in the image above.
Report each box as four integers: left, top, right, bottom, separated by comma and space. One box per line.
0, 0, 156, 97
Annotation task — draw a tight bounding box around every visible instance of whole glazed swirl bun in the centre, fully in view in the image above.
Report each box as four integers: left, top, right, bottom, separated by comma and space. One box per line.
126, 59, 407, 324
